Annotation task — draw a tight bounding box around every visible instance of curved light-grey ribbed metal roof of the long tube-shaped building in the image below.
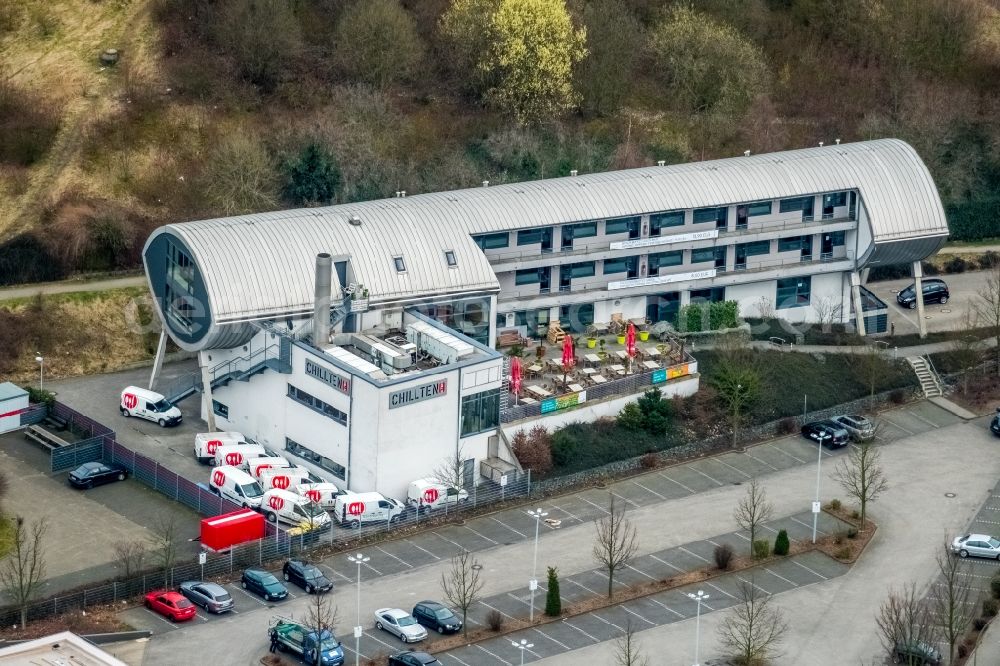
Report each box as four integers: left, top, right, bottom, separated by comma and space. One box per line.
147, 139, 948, 321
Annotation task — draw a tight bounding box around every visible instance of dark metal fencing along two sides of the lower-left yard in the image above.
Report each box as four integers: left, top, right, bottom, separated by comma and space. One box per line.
0, 403, 531, 626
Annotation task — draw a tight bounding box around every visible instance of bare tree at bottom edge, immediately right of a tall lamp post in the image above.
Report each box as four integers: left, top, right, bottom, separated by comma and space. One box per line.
719, 577, 788, 666
